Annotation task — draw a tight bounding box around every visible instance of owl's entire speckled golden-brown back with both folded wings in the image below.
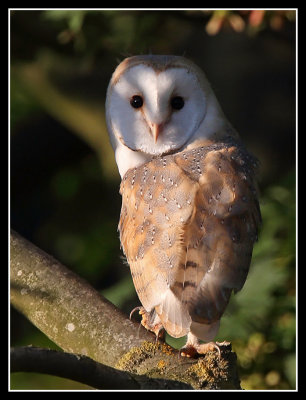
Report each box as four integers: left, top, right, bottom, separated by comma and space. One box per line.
119, 140, 260, 337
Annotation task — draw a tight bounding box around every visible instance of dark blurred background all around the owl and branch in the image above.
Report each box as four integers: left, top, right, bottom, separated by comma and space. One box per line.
10, 10, 296, 389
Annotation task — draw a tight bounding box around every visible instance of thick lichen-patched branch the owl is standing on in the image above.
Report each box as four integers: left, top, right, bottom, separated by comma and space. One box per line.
10, 232, 240, 389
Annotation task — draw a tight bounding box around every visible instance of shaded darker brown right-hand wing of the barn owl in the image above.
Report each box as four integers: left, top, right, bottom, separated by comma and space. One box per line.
176, 142, 261, 332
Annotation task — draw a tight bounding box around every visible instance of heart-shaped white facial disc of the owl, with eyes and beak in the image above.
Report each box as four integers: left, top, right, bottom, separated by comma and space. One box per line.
107, 64, 206, 155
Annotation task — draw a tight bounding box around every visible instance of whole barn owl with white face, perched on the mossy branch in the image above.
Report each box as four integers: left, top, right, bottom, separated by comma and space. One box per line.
106, 55, 260, 356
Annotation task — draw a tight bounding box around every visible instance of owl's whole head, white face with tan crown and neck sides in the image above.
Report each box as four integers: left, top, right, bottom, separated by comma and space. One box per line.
106, 55, 228, 175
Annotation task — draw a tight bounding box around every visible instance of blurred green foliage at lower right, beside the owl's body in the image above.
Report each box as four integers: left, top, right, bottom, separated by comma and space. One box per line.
220, 172, 296, 389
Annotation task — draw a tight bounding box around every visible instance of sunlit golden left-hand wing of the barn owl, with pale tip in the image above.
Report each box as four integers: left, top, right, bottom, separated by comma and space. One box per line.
119, 156, 197, 337
